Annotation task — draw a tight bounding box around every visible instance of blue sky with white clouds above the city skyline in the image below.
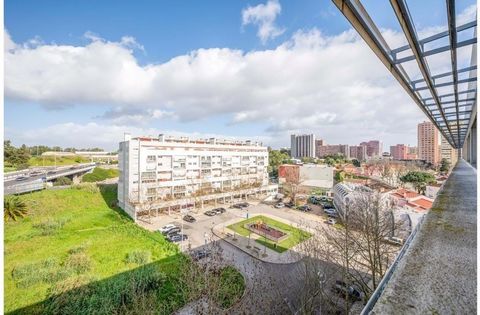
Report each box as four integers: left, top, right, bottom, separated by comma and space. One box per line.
5, 0, 475, 150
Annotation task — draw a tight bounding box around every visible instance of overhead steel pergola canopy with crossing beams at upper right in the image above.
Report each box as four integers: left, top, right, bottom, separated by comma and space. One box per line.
332, 0, 477, 149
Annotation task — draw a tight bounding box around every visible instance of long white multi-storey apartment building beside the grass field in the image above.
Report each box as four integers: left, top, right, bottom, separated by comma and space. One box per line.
118, 134, 278, 220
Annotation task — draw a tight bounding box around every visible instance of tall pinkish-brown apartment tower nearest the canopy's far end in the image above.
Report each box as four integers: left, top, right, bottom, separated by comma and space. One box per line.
418, 121, 440, 165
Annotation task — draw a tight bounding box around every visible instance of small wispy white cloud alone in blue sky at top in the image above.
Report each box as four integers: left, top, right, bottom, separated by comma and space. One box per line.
242, 0, 285, 44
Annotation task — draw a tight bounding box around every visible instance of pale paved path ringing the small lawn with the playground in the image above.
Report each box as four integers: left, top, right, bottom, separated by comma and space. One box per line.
212, 213, 311, 264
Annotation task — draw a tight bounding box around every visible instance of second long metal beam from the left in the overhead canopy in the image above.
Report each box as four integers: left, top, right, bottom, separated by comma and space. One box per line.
390, 0, 460, 148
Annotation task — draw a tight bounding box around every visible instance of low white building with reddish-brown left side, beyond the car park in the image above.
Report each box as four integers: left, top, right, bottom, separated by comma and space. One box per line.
278, 164, 334, 190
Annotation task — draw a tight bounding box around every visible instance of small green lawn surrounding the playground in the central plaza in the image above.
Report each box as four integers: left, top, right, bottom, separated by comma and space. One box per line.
227, 215, 312, 253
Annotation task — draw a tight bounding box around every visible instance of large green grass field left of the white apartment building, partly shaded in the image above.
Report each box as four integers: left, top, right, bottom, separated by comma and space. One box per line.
4, 184, 243, 314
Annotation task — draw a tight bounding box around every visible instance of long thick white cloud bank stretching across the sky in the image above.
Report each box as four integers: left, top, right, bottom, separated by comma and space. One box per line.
5, 3, 470, 146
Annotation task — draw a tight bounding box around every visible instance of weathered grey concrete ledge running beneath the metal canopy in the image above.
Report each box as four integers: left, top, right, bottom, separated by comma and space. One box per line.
372, 160, 477, 314
